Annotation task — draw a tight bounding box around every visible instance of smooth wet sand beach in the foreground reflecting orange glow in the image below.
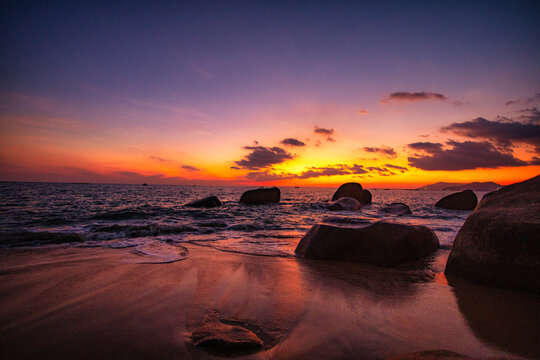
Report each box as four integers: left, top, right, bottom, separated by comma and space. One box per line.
0, 245, 540, 359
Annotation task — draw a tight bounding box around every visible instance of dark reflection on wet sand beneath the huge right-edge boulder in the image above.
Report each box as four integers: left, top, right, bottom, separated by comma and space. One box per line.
448, 277, 540, 358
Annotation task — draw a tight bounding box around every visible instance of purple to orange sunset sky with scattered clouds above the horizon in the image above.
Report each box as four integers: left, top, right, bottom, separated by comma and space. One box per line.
0, 1, 540, 188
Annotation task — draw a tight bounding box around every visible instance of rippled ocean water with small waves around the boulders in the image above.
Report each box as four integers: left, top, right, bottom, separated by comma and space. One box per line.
0, 183, 484, 263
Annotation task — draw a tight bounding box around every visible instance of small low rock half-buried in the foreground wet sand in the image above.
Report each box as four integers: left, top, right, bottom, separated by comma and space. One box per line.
191, 312, 263, 351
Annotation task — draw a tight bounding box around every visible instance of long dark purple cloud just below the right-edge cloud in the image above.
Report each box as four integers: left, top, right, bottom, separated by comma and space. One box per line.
408, 140, 527, 171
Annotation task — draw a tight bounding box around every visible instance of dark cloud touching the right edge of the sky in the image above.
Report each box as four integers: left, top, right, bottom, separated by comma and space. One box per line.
441, 108, 540, 148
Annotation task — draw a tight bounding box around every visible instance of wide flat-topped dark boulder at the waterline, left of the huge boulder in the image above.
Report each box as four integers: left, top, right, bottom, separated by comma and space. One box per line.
294, 221, 439, 266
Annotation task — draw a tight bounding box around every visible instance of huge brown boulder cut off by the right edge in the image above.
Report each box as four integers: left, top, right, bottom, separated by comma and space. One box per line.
445, 176, 540, 293
